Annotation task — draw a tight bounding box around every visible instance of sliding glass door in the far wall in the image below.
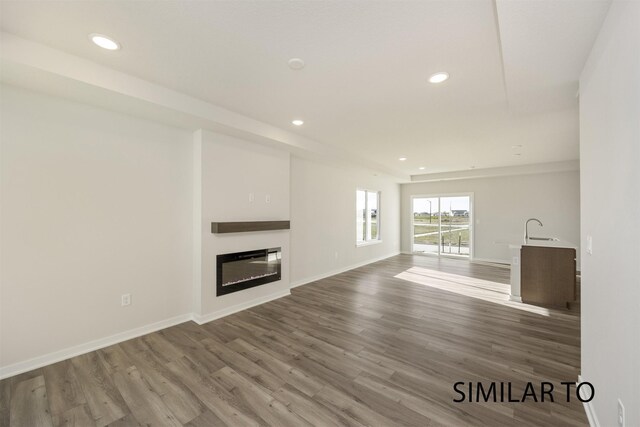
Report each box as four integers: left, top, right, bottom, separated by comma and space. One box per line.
411, 195, 473, 258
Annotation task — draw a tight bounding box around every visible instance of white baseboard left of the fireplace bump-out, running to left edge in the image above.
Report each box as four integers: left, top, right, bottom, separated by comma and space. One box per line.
0, 313, 192, 379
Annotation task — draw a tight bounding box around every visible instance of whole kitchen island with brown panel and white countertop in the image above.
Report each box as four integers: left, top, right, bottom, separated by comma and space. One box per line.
509, 238, 577, 308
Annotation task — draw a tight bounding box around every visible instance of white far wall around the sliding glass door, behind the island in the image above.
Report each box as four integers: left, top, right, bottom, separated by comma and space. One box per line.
402, 171, 580, 265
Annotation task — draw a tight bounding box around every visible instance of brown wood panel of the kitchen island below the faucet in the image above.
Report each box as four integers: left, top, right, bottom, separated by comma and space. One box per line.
520, 246, 576, 308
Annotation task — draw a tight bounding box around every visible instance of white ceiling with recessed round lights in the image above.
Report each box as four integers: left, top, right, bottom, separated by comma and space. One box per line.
1, 0, 609, 175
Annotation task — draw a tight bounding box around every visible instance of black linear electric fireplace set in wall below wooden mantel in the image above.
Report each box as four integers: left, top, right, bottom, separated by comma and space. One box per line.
216, 248, 282, 296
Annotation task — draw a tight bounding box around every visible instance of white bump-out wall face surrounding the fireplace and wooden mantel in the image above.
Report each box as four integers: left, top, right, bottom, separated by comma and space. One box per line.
194, 131, 290, 319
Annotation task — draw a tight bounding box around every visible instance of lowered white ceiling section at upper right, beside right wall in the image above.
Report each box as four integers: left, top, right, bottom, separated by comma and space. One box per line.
496, 0, 609, 113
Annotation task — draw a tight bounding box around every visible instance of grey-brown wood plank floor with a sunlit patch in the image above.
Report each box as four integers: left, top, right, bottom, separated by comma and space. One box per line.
0, 255, 587, 427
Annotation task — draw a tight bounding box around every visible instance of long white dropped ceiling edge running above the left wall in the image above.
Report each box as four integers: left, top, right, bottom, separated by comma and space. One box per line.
0, 32, 410, 181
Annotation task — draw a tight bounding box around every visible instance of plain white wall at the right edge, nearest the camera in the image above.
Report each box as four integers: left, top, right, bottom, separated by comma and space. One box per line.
580, 1, 640, 426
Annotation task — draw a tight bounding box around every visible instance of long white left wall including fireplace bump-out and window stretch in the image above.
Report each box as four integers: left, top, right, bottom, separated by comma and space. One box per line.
0, 86, 400, 377
